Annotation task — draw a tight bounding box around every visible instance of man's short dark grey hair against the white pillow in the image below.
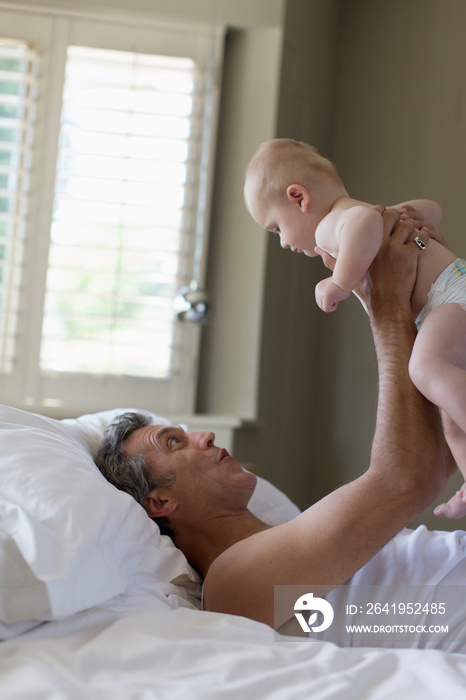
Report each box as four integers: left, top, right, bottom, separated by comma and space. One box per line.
95, 412, 175, 536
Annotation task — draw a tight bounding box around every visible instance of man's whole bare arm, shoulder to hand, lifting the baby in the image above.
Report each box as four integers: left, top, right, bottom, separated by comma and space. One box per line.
204, 212, 446, 626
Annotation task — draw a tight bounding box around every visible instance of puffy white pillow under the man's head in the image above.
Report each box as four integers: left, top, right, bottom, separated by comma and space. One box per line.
0, 406, 299, 639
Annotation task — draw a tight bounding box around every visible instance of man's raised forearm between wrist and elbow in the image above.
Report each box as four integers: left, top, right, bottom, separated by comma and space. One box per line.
369, 291, 446, 517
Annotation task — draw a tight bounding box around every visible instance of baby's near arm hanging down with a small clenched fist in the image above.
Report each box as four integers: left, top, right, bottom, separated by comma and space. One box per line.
316, 206, 383, 312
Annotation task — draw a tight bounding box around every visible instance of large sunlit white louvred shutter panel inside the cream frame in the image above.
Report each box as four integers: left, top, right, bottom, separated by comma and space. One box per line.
41, 47, 203, 379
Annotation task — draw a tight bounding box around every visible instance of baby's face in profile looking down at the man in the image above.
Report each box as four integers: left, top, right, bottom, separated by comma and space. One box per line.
249, 194, 317, 258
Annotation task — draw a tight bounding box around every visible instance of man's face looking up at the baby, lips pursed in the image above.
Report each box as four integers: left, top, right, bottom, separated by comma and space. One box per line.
125, 425, 257, 511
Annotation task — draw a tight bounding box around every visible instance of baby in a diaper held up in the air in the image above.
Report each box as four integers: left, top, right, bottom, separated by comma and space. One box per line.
244, 139, 466, 518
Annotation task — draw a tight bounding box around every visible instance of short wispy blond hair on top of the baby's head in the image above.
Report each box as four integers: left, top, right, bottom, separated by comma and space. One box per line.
244, 139, 341, 208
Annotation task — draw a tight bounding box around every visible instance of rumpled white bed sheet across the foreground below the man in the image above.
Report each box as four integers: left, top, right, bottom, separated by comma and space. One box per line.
0, 604, 466, 700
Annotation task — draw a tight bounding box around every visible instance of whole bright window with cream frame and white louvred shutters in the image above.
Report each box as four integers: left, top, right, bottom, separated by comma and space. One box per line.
0, 6, 221, 415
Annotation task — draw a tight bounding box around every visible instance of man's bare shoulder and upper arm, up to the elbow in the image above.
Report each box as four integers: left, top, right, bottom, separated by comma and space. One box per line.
204, 460, 424, 626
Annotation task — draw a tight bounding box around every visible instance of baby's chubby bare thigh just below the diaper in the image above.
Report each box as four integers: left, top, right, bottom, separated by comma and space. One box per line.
409, 304, 466, 434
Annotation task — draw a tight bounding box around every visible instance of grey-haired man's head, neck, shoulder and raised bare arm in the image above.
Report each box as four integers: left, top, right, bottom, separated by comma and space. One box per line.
97, 209, 452, 627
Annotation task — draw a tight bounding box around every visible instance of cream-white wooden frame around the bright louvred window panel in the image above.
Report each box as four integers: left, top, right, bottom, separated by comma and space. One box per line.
0, 3, 224, 417
